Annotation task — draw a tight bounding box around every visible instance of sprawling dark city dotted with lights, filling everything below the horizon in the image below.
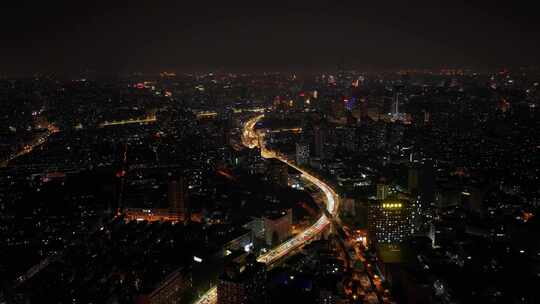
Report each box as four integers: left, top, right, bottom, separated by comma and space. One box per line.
0, 69, 540, 303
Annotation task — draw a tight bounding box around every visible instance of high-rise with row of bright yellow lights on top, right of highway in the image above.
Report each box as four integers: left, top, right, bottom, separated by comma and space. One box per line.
367, 199, 411, 244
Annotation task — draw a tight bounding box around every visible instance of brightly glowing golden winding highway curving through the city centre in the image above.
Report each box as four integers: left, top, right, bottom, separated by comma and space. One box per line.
196, 114, 339, 304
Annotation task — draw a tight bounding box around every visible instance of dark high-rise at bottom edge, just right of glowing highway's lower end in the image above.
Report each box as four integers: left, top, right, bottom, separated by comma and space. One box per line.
217, 258, 266, 304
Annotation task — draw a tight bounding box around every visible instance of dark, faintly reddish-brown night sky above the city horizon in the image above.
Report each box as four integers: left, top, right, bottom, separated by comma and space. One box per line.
0, 0, 540, 75
